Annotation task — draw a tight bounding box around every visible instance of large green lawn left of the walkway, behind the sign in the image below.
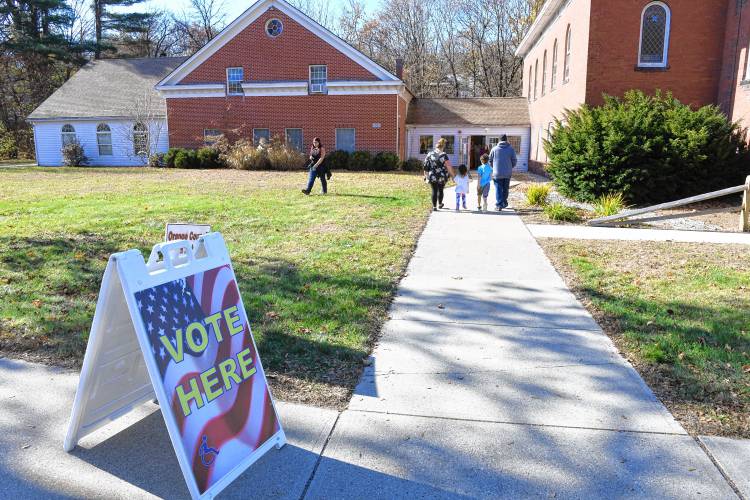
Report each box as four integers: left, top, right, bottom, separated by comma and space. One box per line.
0, 168, 429, 405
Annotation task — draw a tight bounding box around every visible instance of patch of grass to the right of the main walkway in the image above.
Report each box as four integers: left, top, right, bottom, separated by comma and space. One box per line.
542, 240, 750, 438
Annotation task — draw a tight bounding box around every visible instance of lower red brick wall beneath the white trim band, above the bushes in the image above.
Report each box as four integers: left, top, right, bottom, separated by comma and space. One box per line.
167, 95, 398, 152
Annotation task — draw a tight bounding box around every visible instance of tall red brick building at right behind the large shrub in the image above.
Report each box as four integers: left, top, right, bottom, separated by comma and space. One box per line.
516, 0, 750, 172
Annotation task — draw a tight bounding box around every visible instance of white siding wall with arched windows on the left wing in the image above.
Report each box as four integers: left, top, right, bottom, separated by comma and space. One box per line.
34, 120, 169, 167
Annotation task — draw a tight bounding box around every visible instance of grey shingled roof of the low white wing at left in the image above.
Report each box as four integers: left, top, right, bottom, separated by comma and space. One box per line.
28, 57, 186, 120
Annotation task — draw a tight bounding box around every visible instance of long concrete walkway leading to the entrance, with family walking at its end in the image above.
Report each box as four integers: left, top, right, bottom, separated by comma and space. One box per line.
306, 185, 737, 499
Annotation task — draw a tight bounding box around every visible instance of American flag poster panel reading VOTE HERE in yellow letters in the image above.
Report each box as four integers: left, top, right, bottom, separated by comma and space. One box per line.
135, 266, 279, 493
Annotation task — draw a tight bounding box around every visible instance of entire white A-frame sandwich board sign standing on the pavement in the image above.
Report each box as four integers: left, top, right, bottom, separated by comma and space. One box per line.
65, 233, 286, 499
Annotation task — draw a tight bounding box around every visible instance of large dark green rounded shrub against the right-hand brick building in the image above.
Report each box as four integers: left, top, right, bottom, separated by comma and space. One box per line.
545, 91, 750, 203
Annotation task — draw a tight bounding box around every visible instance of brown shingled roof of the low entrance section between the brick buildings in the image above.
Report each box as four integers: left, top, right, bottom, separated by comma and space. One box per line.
406, 97, 531, 126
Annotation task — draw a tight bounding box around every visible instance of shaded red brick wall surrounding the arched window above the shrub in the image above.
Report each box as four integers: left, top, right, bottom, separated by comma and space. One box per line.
586, 0, 727, 106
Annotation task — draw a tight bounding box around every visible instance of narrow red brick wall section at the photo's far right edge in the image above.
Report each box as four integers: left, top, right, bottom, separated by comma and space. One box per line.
717, 0, 750, 127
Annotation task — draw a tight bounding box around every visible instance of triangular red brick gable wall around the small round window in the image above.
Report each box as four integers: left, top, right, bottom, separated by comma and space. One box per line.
180, 10, 378, 83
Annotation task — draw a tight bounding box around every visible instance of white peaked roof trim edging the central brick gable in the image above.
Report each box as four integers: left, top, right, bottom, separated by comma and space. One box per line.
158, 0, 400, 86
